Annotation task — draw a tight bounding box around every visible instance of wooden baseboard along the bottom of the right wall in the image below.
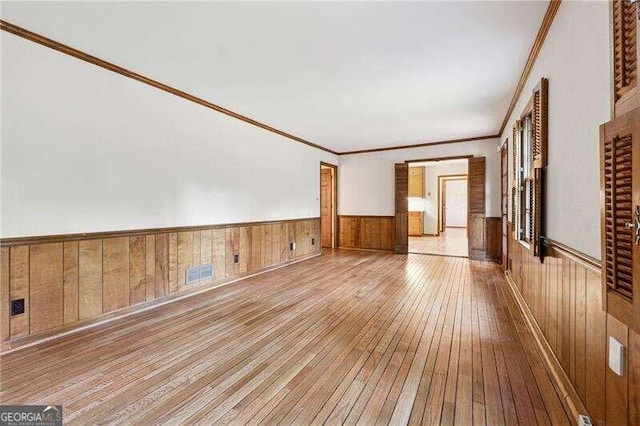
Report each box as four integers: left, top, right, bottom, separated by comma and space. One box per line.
505, 271, 588, 424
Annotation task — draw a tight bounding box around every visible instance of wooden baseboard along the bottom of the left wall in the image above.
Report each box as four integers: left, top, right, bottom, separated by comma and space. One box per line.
0, 253, 322, 355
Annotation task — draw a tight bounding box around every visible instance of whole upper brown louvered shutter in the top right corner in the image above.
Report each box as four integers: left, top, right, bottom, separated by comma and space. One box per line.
611, 0, 640, 117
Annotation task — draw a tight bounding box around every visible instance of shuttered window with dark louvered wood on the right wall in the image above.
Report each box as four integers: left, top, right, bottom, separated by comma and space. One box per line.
511, 79, 548, 258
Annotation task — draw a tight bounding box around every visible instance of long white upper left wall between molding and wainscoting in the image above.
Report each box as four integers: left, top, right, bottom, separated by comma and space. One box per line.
0, 32, 338, 237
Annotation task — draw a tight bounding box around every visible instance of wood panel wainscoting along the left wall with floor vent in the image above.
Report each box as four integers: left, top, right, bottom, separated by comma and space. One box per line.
0, 218, 321, 350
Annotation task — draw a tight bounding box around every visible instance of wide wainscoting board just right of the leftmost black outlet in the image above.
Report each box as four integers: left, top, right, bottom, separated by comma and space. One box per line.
29, 243, 64, 333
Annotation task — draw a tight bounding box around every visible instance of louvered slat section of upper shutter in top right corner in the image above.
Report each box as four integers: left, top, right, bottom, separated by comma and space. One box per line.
612, 0, 638, 101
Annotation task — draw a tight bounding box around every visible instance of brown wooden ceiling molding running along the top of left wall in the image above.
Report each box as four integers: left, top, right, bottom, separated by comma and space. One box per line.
0, 20, 337, 154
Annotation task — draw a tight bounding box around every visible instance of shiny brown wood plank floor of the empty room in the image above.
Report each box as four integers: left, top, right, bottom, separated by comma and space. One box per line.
0, 250, 568, 425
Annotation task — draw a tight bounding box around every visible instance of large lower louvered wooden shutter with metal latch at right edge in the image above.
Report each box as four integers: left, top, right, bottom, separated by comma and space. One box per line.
600, 109, 640, 331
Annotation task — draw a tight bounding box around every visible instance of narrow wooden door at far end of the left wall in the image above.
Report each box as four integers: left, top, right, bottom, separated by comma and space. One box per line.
320, 162, 338, 248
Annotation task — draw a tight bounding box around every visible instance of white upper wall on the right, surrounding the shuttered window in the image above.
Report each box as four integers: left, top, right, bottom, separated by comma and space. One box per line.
501, 2, 611, 259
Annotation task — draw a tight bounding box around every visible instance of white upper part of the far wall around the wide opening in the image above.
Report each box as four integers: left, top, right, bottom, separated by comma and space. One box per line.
338, 139, 500, 217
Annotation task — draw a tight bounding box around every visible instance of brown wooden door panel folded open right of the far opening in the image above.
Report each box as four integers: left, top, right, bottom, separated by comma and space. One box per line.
467, 157, 486, 260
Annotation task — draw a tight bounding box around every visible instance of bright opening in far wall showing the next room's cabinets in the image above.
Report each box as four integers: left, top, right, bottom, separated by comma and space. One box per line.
407, 158, 469, 257
